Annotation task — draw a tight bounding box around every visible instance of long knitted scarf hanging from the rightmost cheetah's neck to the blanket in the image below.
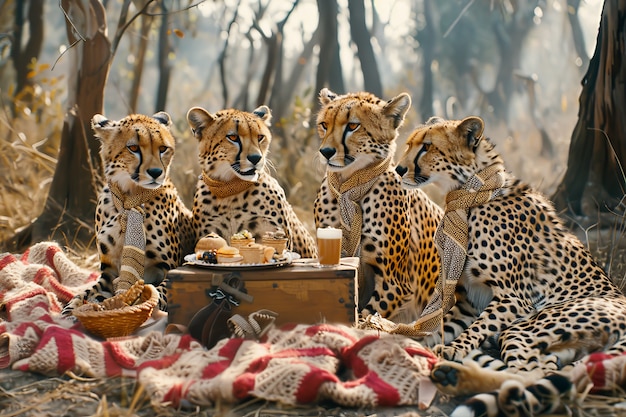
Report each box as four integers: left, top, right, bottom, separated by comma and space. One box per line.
365, 164, 504, 337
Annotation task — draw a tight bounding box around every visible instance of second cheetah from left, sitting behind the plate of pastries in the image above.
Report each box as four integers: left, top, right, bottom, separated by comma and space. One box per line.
187, 106, 317, 258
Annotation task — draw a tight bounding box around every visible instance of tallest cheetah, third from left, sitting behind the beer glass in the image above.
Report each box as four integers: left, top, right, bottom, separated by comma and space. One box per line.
314, 88, 442, 322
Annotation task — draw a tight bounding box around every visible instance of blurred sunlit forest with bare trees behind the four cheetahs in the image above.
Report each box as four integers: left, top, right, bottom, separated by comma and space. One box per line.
0, 0, 612, 264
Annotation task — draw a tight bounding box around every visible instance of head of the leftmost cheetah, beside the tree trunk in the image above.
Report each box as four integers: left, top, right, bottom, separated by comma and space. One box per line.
91, 112, 175, 192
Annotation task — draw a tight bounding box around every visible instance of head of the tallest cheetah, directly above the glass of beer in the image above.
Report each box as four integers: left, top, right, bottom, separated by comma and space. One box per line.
317, 88, 411, 178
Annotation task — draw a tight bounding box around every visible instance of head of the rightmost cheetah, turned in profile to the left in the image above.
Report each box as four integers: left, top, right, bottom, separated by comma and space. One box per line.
396, 117, 487, 192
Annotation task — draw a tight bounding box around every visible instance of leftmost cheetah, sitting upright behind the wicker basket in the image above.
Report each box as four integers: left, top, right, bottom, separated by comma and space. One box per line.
64, 112, 195, 314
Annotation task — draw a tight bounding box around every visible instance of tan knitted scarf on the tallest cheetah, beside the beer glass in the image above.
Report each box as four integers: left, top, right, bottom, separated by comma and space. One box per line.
328, 157, 391, 256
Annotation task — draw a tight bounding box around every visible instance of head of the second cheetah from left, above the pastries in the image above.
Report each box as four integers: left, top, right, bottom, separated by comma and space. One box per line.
187, 106, 272, 181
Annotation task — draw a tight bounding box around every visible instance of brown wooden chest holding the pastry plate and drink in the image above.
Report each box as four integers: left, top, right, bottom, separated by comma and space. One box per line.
168, 258, 358, 325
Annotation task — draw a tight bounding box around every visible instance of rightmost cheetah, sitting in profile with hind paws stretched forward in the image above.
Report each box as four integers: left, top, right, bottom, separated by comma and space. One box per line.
396, 116, 626, 416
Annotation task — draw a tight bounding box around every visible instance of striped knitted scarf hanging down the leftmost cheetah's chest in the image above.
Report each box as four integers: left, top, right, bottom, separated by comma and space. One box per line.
109, 183, 159, 294
